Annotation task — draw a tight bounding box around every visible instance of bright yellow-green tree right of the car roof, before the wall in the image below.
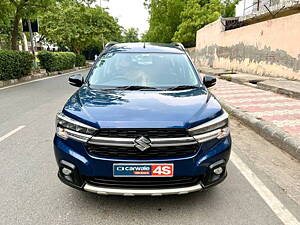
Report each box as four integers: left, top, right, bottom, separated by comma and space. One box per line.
172, 0, 225, 47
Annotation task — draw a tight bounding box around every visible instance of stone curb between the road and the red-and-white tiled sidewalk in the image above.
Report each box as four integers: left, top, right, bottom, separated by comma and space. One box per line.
219, 100, 300, 160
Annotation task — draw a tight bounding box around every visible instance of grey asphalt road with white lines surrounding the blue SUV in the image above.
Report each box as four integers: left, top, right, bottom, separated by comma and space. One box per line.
0, 69, 300, 225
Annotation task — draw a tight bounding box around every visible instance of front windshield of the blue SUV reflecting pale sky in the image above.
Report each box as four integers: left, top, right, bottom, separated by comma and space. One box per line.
88, 53, 199, 88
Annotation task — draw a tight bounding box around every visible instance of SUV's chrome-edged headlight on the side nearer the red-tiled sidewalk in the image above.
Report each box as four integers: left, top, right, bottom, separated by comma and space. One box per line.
188, 111, 230, 142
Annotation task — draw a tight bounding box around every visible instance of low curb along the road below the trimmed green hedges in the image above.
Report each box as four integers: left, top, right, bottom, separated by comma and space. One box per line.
0, 65, 91, 89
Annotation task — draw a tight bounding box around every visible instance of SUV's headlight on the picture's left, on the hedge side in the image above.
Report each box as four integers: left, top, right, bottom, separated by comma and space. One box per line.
56, 112, 97, 141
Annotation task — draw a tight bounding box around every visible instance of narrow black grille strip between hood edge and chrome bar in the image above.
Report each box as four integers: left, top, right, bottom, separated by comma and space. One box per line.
95, 128, 189, 138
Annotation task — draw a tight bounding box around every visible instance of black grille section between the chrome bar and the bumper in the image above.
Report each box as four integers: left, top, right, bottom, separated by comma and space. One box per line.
87, 144, 199, 159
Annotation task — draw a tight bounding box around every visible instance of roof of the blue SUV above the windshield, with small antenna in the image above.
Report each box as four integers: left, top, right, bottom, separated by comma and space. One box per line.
105, 42, 185, 54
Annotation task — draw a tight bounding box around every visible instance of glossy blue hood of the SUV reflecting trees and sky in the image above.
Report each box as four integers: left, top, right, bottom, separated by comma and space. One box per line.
63, 86, 222, 128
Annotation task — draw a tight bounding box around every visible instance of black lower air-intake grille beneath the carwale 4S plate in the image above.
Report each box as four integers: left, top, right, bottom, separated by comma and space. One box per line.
84, 177, 200, 188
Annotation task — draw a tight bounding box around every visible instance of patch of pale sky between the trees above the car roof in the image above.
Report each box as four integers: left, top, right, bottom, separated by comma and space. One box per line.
96, 0, 148, 34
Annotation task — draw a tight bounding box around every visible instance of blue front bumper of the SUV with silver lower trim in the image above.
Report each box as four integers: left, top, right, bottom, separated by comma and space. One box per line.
54, 136, 231, 196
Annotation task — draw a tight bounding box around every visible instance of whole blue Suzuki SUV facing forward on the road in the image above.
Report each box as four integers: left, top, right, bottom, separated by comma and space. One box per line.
54, 43, 231, 196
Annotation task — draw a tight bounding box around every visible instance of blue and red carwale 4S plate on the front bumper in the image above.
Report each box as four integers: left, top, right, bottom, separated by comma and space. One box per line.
113, 163, 174, 177
